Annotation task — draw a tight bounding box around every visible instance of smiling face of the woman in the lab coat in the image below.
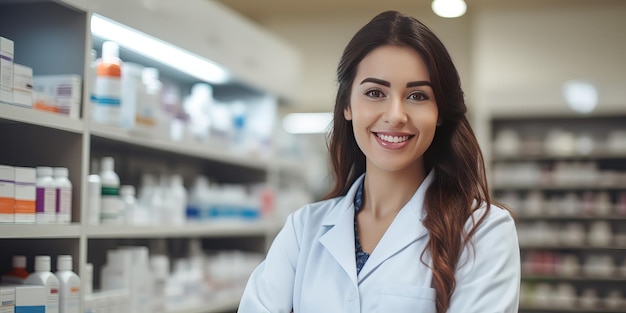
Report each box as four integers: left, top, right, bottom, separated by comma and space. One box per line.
344, 45, 438, 172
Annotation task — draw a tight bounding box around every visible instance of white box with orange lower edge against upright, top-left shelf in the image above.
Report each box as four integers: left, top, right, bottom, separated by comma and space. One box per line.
33, 74, 82, 119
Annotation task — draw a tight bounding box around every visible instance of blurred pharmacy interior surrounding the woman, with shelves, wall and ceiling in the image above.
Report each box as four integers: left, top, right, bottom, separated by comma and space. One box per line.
0, 0, 626, 313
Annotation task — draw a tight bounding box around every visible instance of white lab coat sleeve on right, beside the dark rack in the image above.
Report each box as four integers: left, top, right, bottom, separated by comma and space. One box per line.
448, 206, 521, 313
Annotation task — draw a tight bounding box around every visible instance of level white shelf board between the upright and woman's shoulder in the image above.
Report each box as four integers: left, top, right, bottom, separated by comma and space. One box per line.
85, 221, 279, 239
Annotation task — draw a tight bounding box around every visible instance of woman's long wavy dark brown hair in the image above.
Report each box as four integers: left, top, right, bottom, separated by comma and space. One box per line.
325, 11, 491, 313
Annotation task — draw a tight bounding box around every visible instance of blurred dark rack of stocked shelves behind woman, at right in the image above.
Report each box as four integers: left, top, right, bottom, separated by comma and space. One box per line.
491, 116, 626, 313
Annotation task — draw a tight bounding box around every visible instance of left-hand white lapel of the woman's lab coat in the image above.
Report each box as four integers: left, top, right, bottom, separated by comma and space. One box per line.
319, 175, 363, 286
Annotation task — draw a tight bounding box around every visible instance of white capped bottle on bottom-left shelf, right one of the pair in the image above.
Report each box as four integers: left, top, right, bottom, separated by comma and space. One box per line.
55, 255, 81, 313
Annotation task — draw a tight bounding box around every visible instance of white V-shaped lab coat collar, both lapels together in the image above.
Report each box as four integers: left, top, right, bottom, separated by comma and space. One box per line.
320, 170, 435, 284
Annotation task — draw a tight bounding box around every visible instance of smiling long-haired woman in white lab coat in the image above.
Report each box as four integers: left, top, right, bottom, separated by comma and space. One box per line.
239, 11, 520, 313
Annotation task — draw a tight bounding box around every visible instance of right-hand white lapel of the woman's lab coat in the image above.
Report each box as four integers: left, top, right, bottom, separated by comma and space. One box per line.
358, 171, 435, 283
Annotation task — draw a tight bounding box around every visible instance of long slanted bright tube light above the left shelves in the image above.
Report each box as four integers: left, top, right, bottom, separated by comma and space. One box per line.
91, 14, 229, 84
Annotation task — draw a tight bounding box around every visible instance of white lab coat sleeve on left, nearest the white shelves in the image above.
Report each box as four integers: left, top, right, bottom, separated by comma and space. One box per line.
237, 213, 300, 313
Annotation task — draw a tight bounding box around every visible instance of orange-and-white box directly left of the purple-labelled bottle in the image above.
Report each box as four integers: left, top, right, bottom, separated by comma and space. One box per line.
14, 166, 37, 224
